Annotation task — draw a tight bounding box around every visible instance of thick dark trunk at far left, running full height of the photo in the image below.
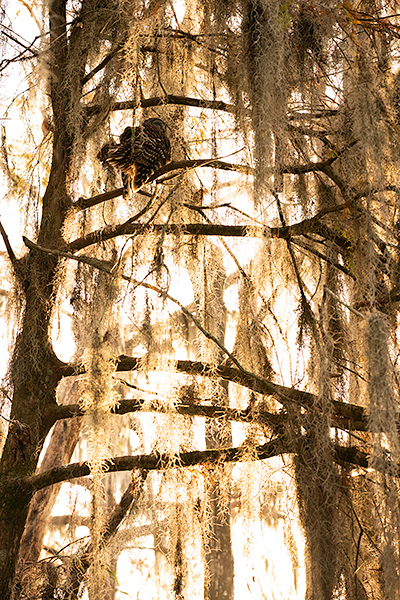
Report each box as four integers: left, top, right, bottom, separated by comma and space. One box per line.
0, 0, 75, 600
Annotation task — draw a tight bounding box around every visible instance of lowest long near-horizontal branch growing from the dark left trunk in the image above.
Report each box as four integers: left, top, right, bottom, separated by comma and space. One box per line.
19, 436, 289, 493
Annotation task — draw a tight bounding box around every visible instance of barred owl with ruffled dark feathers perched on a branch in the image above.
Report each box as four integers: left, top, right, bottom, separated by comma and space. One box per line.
97, 118, 171, 197
